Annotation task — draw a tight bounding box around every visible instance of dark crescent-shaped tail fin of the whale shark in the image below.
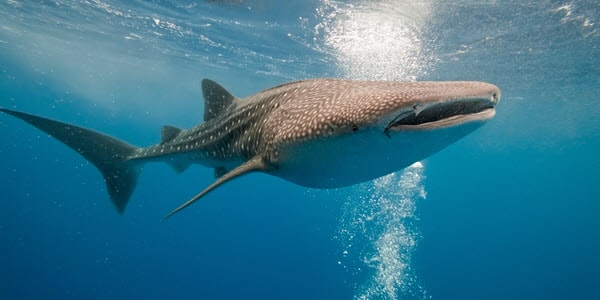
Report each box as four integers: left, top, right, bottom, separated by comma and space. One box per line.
0, 108, 139, 214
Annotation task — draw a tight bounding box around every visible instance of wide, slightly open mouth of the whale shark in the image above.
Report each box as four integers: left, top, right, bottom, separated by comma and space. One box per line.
384, 97, 497, 134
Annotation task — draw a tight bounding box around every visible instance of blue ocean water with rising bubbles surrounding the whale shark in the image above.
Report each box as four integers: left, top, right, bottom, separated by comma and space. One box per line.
0, 0, 600, 299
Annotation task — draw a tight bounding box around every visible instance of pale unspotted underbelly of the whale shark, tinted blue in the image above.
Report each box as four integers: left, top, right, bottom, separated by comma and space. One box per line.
270, 123, 482, 188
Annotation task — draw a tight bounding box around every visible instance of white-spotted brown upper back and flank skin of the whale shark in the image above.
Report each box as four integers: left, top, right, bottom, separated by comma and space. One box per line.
127, 79, 499, 166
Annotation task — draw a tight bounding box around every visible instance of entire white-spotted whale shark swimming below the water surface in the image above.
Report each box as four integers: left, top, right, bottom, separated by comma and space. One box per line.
0, 78, 500, 219
